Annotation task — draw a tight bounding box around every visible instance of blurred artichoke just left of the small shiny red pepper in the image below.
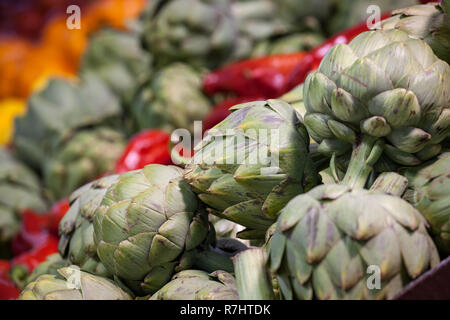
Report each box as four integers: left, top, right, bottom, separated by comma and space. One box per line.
44, 127, 125, 199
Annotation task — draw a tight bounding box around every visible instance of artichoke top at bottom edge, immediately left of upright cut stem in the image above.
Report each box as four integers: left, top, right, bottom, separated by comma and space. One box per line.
149, 270, 239, 300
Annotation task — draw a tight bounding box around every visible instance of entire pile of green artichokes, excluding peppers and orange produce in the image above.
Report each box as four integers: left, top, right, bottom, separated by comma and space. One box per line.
7, 0, 450, 300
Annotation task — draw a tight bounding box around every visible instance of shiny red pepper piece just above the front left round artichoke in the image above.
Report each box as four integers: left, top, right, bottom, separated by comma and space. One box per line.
115, 130, 172, 173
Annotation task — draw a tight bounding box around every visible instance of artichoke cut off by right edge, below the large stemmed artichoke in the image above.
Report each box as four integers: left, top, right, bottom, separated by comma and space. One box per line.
402, 152, 450, 255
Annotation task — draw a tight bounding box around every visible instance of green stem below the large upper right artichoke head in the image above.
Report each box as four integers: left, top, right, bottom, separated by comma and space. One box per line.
342, 134, 383, 189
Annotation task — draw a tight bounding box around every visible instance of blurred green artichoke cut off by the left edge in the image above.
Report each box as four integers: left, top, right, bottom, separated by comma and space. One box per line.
0, 148, 47, 258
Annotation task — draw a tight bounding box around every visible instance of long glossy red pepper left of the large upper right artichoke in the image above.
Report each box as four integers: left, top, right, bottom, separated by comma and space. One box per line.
203, 52, 306, 98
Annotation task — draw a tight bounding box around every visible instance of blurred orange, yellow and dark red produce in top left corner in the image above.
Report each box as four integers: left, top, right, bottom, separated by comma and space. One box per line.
0, 0, 146, 144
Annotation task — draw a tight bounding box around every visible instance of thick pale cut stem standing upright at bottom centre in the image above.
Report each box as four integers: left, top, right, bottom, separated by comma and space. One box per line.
233, 248, 275, 300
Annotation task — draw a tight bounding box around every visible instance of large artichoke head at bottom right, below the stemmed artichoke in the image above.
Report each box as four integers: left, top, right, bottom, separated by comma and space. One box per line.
268, 185, 439, 299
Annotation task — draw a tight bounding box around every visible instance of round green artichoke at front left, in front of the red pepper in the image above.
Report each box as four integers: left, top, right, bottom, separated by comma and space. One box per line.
94, 164, 211, 294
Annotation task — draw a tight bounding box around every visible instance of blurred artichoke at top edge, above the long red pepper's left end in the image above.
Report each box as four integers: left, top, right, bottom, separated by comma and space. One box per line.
143, 0, 238, 68
